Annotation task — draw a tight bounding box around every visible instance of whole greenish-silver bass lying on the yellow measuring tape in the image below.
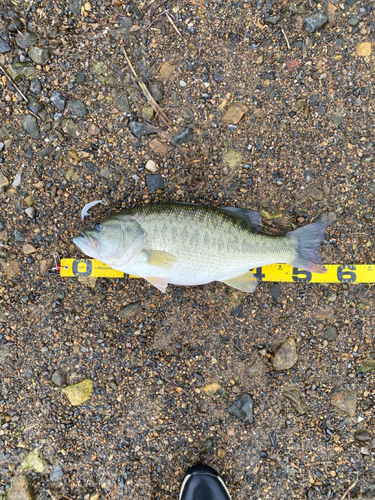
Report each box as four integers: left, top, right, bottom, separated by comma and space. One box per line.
73, 202, 327, 293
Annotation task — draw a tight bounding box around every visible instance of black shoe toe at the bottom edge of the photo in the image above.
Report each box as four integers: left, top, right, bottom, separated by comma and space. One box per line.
179, 465, 231, 500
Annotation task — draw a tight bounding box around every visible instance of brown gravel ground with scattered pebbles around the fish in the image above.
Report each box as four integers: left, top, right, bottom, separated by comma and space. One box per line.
0, 0, 375, 500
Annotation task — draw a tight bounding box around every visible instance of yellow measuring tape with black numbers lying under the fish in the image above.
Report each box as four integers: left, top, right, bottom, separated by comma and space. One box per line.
60, 259, 375, 283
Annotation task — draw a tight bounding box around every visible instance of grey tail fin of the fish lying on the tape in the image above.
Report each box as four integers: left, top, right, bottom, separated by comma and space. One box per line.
286, 222, 327, 273
